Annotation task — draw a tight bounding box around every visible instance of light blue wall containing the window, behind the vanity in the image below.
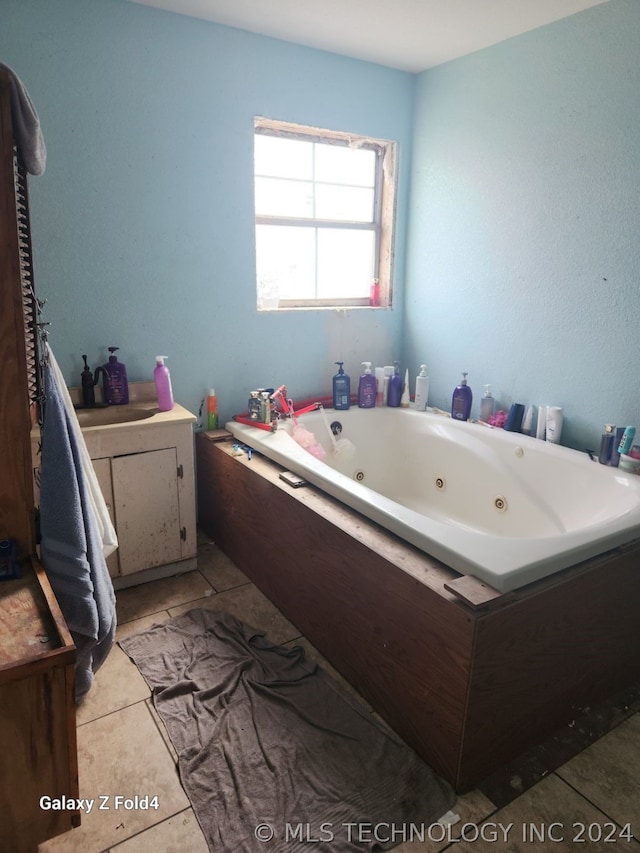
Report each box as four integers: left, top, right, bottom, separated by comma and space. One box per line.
0, 0, 414, 419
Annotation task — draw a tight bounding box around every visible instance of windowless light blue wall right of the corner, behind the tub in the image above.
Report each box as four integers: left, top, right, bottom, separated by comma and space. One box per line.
404, 0, 640, 448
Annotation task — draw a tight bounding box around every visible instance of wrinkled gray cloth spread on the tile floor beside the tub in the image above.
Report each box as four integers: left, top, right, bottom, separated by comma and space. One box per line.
120, 610, 455, 853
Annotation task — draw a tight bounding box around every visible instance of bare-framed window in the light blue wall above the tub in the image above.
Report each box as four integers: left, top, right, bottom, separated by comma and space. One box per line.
254, 118, 395, 310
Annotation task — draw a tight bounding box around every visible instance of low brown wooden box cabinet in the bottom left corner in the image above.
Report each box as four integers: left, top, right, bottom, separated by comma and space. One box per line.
0, 559, 80, 853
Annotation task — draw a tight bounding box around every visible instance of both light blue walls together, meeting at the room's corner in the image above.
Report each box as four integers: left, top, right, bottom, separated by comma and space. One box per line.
0, 0, 640, 848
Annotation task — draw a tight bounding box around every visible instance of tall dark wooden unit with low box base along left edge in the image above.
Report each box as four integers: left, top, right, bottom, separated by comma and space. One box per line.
0, 70, 79, 853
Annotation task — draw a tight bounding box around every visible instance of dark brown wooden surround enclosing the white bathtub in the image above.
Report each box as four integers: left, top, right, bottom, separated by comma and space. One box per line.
196, 432, 640, 793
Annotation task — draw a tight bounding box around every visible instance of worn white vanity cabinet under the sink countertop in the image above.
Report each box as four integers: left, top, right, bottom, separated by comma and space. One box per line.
34, 390, 197, 589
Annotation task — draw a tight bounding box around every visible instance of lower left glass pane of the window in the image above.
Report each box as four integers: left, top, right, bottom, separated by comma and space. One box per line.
256, 225, 316, 308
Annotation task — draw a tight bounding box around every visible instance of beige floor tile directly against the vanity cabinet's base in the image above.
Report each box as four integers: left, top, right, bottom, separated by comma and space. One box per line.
116, 571, 212, 625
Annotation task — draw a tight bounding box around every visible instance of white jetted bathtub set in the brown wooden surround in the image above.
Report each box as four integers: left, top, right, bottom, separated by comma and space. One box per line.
226, 408, 640, 592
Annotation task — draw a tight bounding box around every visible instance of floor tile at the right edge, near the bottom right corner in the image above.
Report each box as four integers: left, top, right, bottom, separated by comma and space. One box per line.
557, 714, 640, 838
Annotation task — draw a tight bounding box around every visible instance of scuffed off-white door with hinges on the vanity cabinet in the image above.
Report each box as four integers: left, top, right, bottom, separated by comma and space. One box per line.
111, 447, 182, 575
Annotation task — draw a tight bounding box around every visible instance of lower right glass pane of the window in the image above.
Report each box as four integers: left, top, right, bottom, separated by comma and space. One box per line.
318, 228, 375, 299
